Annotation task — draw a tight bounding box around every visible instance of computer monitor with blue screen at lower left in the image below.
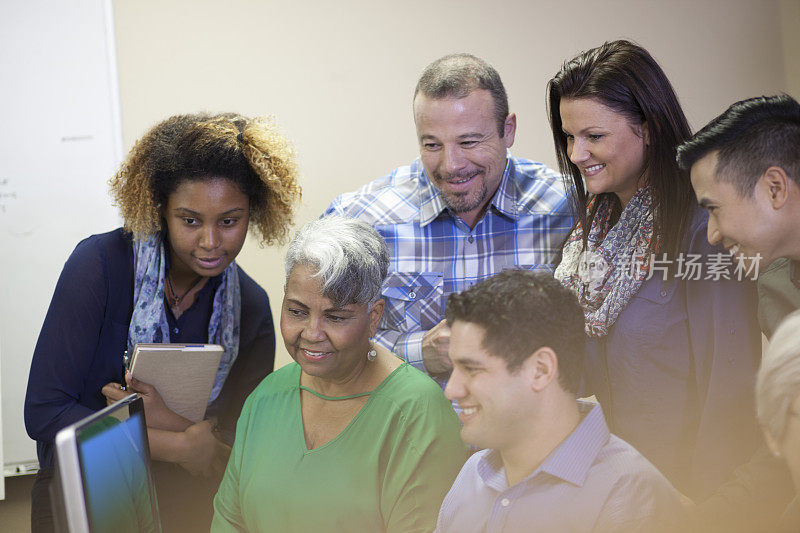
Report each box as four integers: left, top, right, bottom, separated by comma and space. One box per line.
54, 394, 161, 533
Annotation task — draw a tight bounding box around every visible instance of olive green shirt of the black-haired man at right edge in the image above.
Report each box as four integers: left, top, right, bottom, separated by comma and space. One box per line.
758, 258, 800, 338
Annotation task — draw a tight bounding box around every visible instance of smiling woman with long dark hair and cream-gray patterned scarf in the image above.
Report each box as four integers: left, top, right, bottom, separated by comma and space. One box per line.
548, 41, 761, 498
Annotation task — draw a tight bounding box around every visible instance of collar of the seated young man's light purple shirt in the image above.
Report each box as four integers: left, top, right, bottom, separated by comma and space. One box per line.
478, 400, 611, 491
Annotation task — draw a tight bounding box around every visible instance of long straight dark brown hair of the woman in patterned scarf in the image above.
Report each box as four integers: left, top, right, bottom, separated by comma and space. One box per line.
547, 40, 695, 255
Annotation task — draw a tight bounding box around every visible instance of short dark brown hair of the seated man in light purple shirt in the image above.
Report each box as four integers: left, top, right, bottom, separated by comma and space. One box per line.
445, 270, 586, 394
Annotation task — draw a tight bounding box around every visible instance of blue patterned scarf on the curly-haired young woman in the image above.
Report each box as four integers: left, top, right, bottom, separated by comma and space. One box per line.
128, 233, 242, 403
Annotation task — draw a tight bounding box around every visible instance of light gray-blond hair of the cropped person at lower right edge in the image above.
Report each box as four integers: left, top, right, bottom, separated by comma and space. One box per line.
756, 311, 800, 441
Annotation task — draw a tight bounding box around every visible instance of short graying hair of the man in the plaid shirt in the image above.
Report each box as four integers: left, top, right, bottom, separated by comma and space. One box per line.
414, 54, 508, 137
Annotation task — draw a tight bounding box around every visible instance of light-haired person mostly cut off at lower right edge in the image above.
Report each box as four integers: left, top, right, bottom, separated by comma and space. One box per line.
756, 311, 800, 532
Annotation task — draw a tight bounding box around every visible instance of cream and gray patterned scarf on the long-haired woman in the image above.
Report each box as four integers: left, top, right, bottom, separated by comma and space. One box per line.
555, 187, 654, 337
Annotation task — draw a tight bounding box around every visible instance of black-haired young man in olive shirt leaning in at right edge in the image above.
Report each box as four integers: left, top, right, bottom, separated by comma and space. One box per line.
678, 95, 800, 336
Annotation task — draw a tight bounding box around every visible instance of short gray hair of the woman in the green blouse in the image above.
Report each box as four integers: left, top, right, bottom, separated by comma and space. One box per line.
284, 215, 389, 307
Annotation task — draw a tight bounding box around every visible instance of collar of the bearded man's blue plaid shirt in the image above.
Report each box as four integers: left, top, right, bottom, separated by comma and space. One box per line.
411, 152, 519, 227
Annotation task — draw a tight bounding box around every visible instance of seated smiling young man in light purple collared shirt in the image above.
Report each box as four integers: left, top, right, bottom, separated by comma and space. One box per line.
436, 270, 684, 533
